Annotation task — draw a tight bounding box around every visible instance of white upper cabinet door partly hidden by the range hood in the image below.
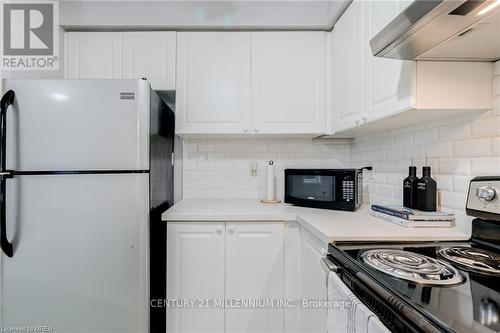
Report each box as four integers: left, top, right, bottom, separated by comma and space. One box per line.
359, 1, 415, 122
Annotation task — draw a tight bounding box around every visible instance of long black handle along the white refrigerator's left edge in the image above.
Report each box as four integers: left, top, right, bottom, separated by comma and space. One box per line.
0, 90, 16, 257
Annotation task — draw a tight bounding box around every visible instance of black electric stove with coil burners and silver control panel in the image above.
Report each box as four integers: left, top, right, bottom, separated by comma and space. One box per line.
327, 177, 500, 333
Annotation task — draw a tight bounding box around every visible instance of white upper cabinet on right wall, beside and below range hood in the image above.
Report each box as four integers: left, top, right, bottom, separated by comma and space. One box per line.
327, 0, 493, 134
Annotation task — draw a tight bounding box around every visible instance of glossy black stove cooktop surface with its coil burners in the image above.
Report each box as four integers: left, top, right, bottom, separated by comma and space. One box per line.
338, 242, 500, 333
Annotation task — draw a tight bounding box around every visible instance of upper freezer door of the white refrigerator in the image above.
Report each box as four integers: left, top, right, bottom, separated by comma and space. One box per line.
3, 80, 150, 171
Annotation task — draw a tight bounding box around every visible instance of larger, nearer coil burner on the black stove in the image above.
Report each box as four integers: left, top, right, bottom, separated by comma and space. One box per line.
361, 249, 463, 285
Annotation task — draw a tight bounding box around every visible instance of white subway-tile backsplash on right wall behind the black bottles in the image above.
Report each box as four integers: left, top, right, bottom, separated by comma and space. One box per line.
351, 62, 500, 232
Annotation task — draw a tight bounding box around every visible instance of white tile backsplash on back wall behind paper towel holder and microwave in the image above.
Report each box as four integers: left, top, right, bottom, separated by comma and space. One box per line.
183, 139, 350, 199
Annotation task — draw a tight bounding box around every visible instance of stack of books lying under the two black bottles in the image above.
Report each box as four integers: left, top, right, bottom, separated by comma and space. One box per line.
371, 205, 455, 228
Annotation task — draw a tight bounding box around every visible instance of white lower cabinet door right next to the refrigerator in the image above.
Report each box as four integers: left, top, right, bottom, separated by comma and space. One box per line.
167, 222, 225, 333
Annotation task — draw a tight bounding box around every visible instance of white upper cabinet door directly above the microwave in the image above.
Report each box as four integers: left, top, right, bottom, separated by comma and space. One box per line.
251, 32, 325, 134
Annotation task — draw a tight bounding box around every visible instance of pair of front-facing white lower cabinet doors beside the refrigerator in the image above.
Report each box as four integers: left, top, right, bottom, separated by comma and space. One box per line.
167, 222, 284, 333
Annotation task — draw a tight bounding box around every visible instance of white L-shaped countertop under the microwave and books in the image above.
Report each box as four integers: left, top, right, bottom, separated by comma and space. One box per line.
162, 199, 470, 243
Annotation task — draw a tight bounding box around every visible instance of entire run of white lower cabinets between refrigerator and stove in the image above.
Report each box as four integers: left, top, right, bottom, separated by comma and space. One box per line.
167, 221, 328, 333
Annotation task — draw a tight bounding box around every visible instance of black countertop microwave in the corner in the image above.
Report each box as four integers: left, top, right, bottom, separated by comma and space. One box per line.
285, 169, 363, 211
